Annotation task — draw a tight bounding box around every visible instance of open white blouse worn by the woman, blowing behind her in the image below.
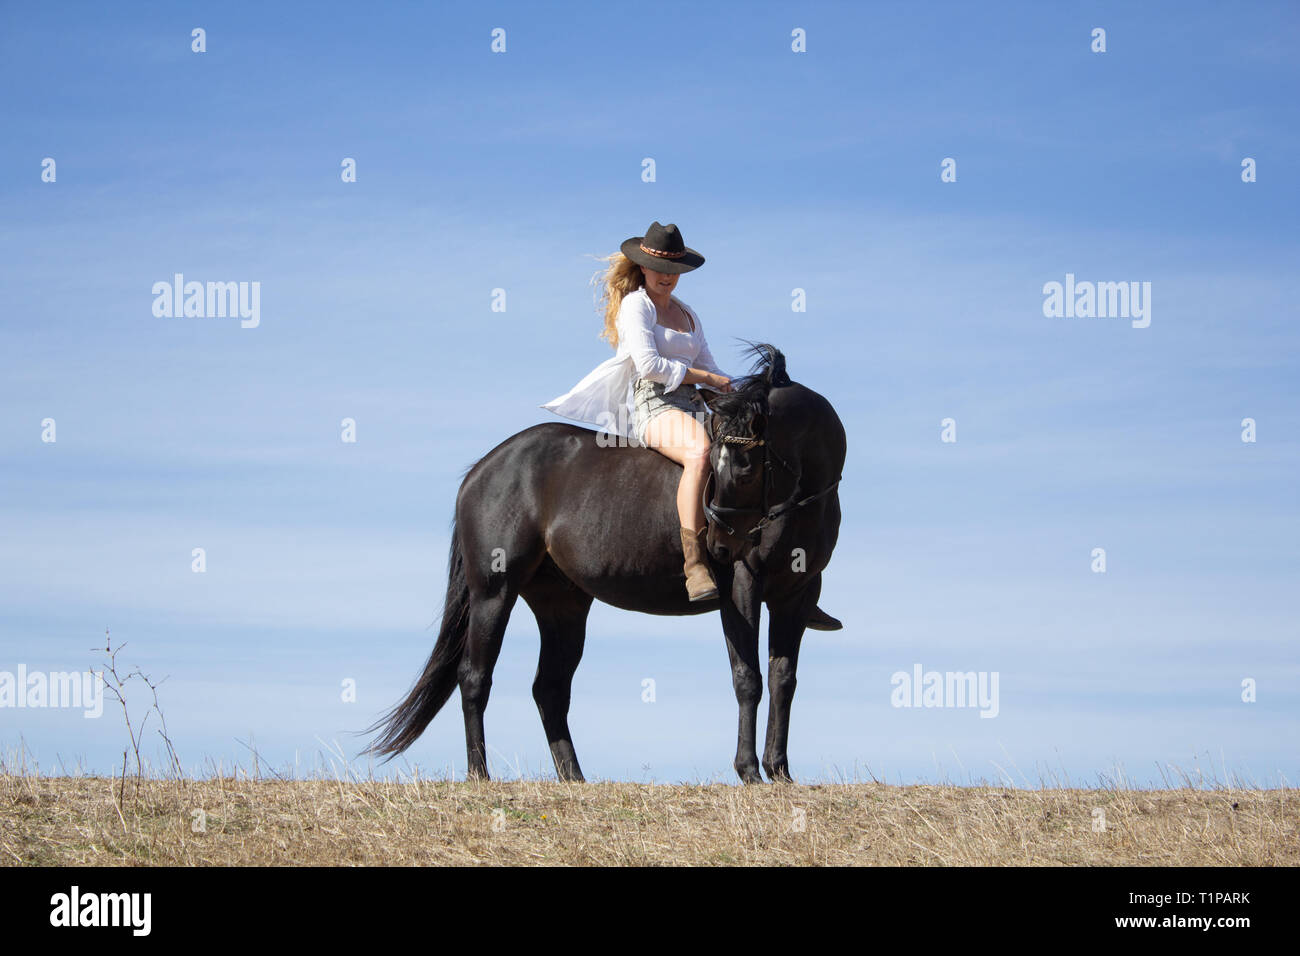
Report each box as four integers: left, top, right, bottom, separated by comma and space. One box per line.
541, 287, 731, 438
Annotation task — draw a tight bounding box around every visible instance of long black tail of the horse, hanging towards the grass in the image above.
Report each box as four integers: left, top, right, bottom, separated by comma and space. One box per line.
365, 523, 469, 757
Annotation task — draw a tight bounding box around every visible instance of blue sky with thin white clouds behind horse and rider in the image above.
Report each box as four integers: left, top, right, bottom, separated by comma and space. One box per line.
0, 3, 1300, 786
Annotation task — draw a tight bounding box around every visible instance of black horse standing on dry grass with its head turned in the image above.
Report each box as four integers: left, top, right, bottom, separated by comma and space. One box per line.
367, 345, 845, 783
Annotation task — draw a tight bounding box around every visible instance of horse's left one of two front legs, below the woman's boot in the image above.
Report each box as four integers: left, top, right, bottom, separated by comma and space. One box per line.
718, 564, 763, 783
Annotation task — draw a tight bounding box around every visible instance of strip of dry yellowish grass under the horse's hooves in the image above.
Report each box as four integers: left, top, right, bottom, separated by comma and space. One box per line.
0, 773, 1300, 866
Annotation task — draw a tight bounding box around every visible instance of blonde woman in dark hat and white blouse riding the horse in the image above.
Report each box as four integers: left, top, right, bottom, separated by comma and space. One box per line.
542, 221, 840, 630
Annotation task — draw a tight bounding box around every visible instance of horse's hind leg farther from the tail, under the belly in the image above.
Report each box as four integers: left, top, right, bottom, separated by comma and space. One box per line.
524, 572, 592, 782
